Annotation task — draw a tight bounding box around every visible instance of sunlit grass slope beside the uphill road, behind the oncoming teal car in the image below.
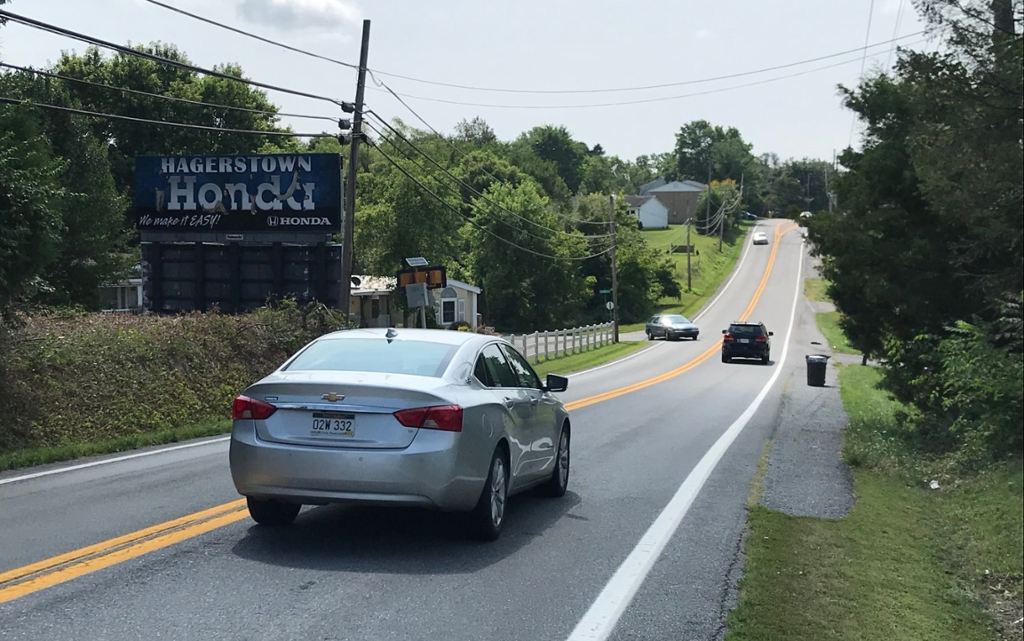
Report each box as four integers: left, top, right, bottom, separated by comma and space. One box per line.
621, 222, 751, 332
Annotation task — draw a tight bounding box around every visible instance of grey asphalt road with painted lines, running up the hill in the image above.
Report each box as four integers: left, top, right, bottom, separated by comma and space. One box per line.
0, 221, 815, 641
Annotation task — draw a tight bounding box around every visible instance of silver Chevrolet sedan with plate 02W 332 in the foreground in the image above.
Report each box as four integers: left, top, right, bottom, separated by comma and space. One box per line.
230, 329, 570, 541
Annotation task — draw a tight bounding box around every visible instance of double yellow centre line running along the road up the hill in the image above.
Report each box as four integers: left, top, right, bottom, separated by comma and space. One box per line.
0, 224, 796, 603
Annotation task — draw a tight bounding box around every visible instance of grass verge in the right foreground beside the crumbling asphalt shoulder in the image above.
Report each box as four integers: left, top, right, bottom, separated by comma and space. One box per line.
728, 366, 1024, 641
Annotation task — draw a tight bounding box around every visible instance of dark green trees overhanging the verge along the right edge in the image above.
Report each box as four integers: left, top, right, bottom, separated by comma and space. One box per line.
809, 0, 1024, 462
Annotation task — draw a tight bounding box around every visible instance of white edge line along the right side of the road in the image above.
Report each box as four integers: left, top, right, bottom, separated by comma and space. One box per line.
567, 237, 804, 641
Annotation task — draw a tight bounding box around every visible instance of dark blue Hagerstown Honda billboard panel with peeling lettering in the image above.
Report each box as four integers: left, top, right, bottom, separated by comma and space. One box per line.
135, 154, 343, 233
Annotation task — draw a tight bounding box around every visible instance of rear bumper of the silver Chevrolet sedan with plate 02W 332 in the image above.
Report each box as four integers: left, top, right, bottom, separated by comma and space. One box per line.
228, 421, 483, 510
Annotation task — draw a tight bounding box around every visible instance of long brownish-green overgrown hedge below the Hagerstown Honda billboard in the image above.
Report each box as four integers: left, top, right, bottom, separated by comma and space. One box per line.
0, 301, 343, 451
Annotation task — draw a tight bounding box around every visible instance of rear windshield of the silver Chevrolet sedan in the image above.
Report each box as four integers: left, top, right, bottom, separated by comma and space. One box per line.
285, 338, 459, 377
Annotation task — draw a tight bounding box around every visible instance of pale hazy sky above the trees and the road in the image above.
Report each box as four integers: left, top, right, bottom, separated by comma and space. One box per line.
0, 0, 932, 160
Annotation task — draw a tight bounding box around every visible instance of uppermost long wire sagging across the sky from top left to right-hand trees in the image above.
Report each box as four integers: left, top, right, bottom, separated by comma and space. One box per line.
132, 0, 925, 99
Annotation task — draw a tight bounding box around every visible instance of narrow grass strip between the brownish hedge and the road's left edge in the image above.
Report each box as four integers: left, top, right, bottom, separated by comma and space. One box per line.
0, 419, 231, 472
